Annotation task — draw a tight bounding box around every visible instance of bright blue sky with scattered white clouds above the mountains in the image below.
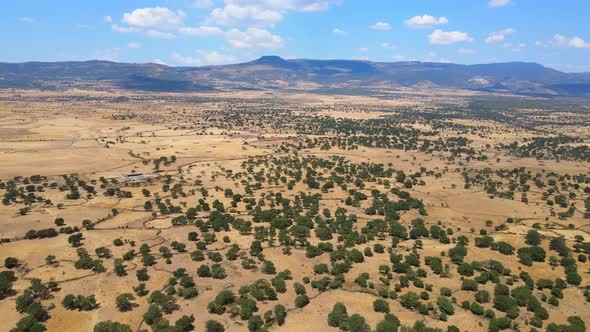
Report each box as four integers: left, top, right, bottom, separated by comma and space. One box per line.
0, 0, 590, 72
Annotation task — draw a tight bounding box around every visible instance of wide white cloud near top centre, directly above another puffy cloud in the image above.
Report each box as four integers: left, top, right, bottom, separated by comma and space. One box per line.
210, 3, 283, 26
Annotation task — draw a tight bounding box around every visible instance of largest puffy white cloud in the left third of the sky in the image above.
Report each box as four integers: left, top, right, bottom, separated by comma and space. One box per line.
122, 7, 185, 29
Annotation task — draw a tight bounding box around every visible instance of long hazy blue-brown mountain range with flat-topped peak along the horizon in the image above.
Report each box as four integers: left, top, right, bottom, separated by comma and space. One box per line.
0, 56, 590, 97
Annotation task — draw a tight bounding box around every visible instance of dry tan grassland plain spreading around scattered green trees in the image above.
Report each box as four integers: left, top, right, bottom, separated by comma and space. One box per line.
0, 91, 590, 332
